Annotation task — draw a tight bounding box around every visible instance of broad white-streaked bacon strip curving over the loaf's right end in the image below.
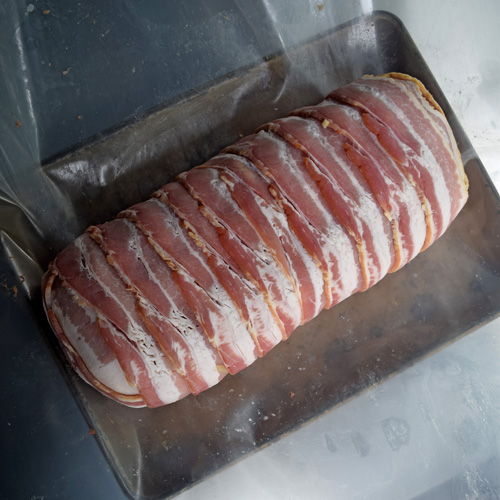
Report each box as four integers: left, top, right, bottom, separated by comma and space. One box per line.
330, 77, 467, 248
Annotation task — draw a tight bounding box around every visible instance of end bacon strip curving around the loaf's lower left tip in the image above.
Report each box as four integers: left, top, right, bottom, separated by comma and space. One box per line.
44, 274, 145, 407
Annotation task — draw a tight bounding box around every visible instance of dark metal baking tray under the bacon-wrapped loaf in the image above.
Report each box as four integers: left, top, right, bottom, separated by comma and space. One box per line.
10, 13, 500, 498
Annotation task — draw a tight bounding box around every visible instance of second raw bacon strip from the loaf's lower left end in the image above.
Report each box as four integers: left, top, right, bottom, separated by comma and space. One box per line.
52, 234, 190, 407
